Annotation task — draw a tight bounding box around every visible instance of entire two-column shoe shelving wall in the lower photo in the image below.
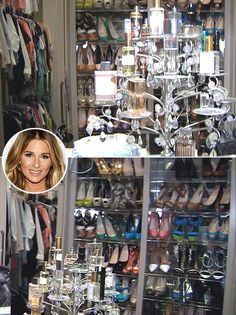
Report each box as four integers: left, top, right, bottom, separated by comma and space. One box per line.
62, 158, 236, 315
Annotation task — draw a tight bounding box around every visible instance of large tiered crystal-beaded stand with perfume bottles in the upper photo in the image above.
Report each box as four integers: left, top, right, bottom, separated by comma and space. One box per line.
74, 7, 236, 157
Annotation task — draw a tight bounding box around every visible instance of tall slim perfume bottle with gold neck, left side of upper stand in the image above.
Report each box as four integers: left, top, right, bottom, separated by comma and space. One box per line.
122, 19, 135, 75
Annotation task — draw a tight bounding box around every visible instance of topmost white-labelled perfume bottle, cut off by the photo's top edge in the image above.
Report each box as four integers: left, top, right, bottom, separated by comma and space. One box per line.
149, 0, 164, 36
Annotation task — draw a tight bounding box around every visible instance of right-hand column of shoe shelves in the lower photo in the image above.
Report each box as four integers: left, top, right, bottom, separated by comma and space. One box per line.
139, 159, 231, 314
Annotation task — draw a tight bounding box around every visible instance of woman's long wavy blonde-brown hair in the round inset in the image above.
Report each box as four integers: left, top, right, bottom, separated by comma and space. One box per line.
5, 129, 65, 190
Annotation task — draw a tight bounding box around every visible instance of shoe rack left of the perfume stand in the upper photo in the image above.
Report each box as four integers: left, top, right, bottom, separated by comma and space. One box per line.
76, 1, 147, 137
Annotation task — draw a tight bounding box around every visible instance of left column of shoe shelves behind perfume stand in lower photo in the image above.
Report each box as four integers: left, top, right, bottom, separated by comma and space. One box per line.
74, 158, 143, 314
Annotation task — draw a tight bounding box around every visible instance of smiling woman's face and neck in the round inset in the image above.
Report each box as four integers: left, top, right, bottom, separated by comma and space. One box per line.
20, 139, 52, 192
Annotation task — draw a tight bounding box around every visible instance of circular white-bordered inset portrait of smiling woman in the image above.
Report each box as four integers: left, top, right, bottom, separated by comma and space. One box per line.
2, 128, 68, 194
